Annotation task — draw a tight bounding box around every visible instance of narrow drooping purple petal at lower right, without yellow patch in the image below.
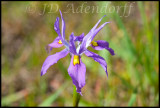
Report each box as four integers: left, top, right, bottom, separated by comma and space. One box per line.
84, 50, 108, 77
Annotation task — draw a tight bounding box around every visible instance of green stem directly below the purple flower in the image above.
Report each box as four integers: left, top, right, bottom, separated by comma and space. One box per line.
73, 85, 80, 107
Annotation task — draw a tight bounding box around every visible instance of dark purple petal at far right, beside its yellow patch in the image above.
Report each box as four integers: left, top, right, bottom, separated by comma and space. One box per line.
91, 40, 115, 55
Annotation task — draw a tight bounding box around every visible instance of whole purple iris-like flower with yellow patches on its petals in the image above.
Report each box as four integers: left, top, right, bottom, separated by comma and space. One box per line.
41, 11, 114, 95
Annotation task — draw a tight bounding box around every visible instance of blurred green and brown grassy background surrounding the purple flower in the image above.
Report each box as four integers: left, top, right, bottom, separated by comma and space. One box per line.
1, 1, 159, 106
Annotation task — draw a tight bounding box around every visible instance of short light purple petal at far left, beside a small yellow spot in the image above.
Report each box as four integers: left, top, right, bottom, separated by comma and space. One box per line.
46, 37, 63, 53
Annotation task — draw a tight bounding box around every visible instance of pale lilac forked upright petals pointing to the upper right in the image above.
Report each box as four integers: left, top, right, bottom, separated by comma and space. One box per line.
79, 16, 109, 53
